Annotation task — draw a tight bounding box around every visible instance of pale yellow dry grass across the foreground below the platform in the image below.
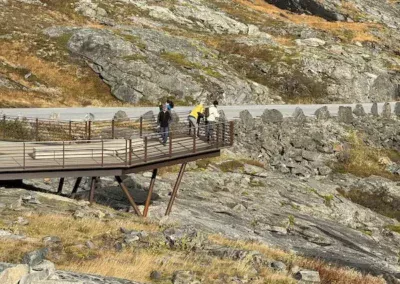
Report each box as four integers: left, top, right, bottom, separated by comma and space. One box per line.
0, 209, 385, 284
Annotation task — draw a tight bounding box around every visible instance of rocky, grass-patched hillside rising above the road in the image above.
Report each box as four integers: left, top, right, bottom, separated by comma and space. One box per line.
0, 0, 400, 105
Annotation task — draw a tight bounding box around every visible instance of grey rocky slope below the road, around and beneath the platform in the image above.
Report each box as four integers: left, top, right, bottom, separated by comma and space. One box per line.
0, 106, 400, 283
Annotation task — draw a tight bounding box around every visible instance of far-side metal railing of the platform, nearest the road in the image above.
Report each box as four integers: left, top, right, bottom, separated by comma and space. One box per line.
0, 112, 192, 141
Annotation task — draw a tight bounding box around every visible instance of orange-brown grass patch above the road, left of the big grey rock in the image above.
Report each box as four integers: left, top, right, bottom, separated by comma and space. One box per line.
0, 42, 129, 107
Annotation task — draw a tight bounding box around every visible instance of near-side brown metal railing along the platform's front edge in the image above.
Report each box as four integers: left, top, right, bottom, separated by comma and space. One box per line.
0, 121, 234, 172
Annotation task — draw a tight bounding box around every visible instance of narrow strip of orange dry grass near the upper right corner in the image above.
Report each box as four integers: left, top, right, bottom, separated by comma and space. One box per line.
235, 0, 381, 41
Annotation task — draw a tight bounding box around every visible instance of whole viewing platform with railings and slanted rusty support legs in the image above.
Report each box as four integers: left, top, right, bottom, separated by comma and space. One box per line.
0, 114, 234, 216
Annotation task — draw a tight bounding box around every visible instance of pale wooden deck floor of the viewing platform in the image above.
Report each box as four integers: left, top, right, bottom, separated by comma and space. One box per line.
0, 136, 219, 172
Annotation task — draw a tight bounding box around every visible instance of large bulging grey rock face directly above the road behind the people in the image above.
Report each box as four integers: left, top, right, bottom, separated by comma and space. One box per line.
63, 28, 272, 104
